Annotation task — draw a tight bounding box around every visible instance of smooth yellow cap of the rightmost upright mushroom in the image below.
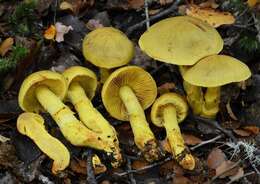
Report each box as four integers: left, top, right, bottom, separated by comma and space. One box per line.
183, 55, 251, 87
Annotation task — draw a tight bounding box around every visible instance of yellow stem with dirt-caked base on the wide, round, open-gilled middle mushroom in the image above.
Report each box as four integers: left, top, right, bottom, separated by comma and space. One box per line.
119, 86, 159, 161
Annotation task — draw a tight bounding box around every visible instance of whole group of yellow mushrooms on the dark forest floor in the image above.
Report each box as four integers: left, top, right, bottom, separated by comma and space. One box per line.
17, 16, 251, 173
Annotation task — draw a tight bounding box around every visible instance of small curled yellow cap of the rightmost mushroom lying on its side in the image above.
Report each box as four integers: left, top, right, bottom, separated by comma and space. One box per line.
151, 93, 189, 127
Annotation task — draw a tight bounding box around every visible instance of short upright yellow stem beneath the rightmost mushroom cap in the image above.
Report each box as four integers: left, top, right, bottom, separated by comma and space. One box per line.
201, 87, 221, 118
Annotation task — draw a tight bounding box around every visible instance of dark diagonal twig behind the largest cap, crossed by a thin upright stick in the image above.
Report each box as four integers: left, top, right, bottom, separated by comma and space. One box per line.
126, 0, 181, 35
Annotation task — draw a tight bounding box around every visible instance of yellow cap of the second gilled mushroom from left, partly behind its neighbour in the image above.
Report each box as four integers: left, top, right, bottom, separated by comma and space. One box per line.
62, 66, 97, 99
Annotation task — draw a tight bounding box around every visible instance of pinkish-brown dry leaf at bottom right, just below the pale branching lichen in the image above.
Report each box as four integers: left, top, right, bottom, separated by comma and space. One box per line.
216, 160, 239, 178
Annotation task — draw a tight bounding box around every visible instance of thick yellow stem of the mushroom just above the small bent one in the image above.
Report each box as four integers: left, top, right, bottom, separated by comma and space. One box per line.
35, 85, 111, 151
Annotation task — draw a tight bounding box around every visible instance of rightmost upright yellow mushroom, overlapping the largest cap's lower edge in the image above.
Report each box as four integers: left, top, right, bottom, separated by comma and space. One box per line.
183, 55, 251, 118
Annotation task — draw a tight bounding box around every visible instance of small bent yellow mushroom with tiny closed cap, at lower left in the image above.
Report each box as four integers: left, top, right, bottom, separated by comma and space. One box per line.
17, 112, 70, 174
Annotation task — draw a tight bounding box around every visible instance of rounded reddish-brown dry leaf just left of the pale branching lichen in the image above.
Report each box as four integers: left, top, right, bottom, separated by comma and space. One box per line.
207, 148, 226, 169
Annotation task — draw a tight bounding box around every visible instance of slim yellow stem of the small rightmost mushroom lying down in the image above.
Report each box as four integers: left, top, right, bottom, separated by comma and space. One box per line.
163, 105, 195, 170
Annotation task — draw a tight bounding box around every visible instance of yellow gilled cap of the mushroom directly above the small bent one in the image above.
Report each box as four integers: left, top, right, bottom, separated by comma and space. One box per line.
18, 70, 67, 113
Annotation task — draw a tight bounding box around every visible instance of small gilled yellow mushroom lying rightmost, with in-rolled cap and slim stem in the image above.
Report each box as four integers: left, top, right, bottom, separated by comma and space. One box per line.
151, 93, 195, 170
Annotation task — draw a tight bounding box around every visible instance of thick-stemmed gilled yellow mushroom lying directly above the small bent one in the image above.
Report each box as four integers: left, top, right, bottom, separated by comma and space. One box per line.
18, 70, 111, 152
